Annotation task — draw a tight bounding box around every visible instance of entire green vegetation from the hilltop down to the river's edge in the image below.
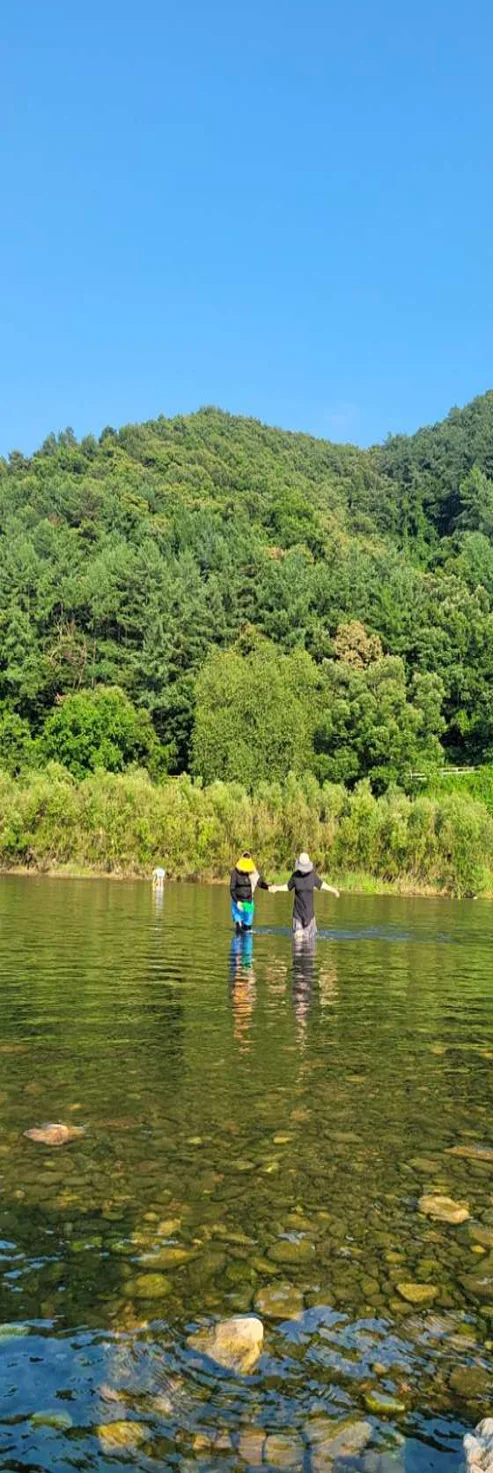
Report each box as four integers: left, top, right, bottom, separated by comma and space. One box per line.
0, 393, 493, 890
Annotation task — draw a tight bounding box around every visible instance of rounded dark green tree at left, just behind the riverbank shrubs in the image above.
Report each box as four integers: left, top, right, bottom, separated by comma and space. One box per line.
38, 685, 163, 778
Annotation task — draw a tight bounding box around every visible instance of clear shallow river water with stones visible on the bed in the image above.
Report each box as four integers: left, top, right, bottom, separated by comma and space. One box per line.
0, 876, 493, 1473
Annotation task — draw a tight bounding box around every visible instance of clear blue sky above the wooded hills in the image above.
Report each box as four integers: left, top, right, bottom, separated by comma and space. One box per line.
0, 0, 493, 452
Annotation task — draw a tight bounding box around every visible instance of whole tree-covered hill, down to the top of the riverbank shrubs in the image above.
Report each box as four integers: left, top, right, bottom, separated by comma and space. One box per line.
0, 393, 493, 790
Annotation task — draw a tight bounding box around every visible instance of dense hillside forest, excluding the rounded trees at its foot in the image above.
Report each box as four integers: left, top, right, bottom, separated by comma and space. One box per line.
0, 393, 493, 782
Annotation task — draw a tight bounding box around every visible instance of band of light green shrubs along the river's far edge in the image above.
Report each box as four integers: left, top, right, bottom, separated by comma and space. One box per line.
0, 763, 493, 896
